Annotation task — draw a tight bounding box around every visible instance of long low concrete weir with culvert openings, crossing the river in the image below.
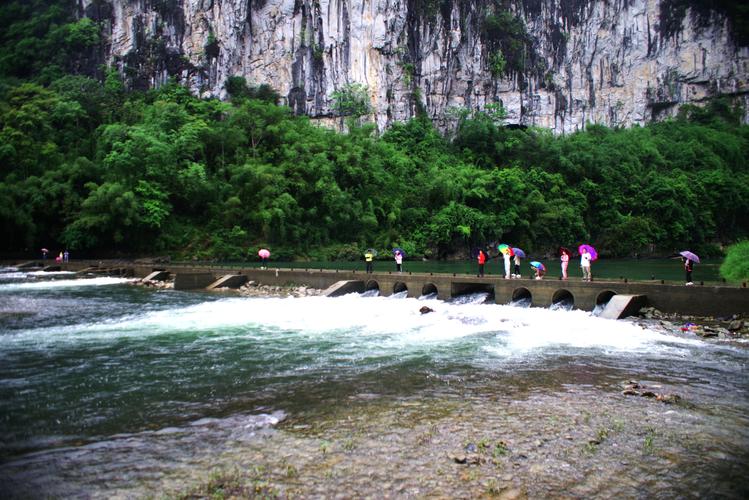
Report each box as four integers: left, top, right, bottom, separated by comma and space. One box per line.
43, 262, 749, 317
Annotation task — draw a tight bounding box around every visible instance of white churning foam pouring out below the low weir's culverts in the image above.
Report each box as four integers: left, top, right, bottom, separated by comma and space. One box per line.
0, 292, 699, 358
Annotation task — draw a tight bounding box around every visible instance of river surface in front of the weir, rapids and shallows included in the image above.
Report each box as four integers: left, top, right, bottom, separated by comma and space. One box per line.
0, 268, 749, 498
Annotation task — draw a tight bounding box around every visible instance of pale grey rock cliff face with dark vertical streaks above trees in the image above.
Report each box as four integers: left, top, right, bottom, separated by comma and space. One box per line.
79, 0, 749, 133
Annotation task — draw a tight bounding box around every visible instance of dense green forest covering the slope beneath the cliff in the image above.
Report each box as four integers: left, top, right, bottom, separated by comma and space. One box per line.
0, 1, 749, 260
